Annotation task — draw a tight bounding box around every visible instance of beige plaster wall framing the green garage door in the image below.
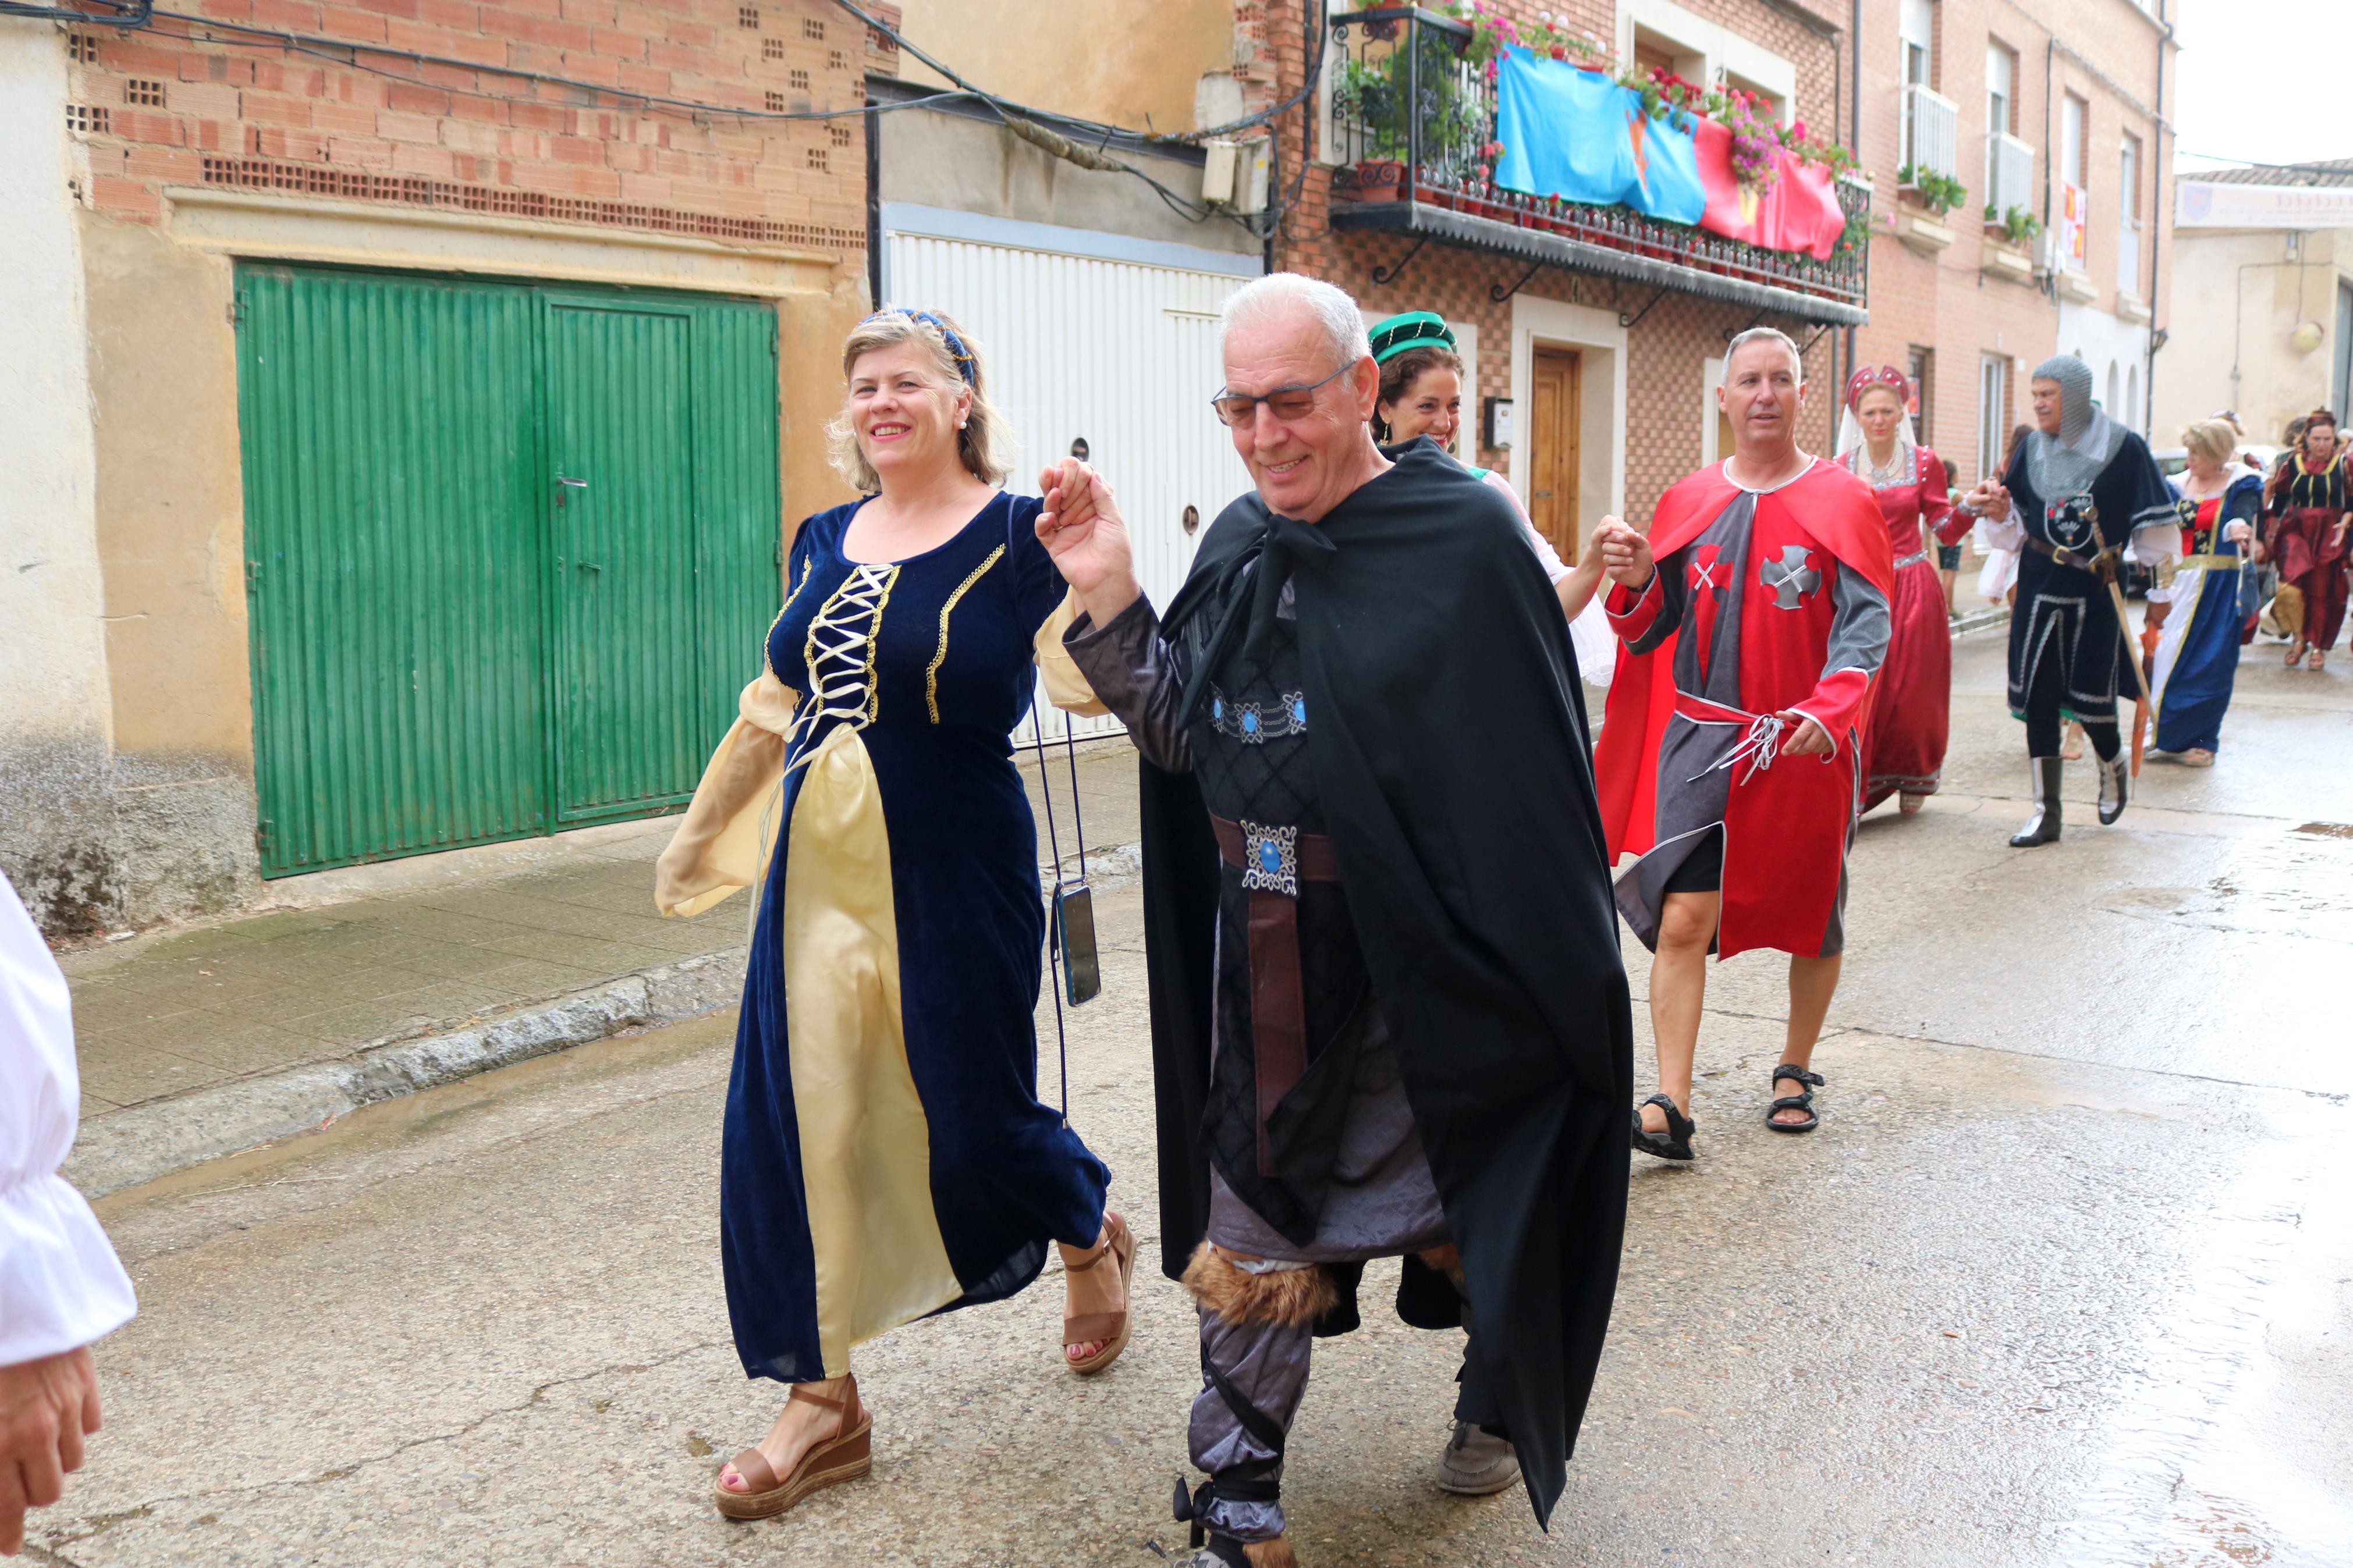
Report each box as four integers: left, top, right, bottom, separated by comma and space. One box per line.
62, 195, 866, 924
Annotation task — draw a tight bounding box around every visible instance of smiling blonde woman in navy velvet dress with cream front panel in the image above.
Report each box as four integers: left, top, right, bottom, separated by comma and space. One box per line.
656, 310, 1134, 1519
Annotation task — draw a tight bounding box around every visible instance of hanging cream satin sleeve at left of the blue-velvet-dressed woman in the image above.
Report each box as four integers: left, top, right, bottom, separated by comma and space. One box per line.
654, 670, 800, 917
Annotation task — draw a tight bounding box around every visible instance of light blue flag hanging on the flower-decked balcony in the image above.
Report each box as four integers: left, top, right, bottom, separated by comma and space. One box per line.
1494, 49, 1708, 223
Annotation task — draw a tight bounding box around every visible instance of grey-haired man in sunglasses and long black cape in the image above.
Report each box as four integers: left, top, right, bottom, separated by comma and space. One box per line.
1038, 273, 1633, 1568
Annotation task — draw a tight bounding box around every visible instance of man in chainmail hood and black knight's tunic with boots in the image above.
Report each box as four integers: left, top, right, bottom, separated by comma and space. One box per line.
1969, 355, 2177, 849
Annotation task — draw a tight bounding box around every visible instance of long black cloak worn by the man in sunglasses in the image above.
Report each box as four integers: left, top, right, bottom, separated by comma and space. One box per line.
1141, 440, 1633, 1523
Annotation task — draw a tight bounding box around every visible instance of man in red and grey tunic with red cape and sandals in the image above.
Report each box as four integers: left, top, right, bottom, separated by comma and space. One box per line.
1595, 327, 1894, 1159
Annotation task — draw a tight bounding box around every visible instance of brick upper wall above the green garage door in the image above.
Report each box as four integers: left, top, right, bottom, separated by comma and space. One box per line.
68, 0, 896, 251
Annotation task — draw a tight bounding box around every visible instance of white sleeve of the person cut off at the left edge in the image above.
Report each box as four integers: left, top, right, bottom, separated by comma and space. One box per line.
0, 877, 139, 1366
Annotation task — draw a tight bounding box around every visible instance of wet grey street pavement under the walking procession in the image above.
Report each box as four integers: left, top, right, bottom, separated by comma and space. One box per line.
33, 635, 2353, 1568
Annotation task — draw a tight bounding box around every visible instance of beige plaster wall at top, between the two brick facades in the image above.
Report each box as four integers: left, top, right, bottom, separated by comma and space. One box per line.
899, 0, 1236, 131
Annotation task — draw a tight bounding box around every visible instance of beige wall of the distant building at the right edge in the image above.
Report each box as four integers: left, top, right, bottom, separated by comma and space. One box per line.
2153, 228, 2353, 447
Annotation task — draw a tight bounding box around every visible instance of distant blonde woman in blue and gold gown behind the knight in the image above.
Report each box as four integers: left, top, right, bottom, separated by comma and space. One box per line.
2148, 418, 2263, 769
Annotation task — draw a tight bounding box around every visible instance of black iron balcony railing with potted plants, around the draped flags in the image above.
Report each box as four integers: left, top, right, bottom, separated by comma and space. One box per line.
1325, 7, 1871, 322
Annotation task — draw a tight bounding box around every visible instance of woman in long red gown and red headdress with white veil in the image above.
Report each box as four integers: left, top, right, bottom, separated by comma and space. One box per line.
1838, 364, 1976, 816
